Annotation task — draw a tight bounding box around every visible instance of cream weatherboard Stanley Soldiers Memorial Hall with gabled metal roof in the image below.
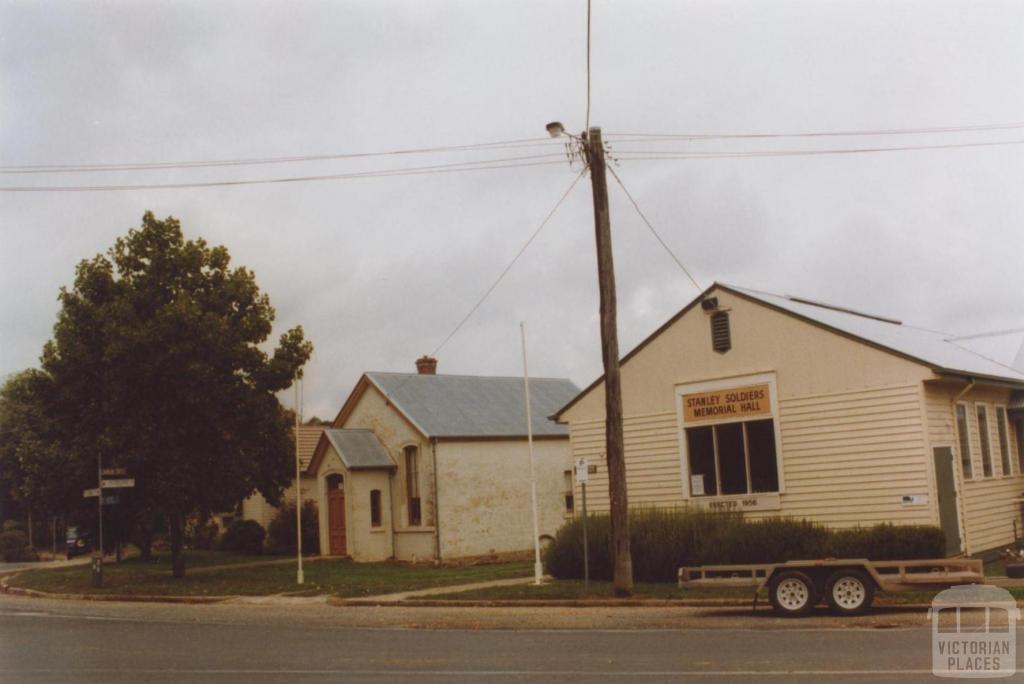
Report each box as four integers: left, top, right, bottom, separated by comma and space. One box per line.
554, 284, 1024, 555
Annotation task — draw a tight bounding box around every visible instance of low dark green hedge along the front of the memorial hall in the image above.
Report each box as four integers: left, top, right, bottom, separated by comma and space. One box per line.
545, 509, 945, 582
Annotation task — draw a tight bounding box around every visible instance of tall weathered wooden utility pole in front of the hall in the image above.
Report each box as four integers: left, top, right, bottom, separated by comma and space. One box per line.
584, 126, 633, 596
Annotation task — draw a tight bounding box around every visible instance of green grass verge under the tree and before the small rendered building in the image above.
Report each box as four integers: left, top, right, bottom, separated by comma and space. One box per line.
10, 551, 532, 598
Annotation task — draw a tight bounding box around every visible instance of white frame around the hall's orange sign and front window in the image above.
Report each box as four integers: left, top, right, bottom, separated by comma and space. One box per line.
676, 373, 785, 501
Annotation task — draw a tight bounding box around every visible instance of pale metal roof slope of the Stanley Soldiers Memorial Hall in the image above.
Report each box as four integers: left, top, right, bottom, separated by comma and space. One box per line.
722, 285, 1024, 383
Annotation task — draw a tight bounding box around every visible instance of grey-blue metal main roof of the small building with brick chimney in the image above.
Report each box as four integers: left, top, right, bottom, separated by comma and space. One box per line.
367, 373, 580, 437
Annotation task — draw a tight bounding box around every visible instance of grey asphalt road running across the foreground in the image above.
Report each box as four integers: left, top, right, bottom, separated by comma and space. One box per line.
0, 597, 1024, 683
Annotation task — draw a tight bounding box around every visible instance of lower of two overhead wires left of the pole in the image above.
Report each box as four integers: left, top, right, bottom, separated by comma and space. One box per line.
0, 153, 564, 193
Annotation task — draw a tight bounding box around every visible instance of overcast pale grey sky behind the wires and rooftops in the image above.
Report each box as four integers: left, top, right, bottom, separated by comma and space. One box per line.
0, 0, 1024, 418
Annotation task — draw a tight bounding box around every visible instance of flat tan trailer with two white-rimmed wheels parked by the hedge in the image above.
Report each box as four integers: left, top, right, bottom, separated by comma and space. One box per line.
679, 558, 984, 616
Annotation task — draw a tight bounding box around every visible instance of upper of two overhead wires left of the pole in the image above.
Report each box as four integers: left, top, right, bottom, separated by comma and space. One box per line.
0, 138, 557, 174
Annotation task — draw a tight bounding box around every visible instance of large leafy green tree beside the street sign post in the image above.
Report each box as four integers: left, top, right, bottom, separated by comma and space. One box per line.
43, 212, 312, 576
